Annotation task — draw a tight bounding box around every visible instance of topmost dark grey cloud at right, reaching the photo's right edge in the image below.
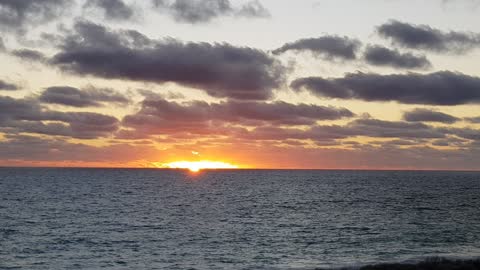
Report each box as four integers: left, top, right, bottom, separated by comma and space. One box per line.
377, 20, 480, 53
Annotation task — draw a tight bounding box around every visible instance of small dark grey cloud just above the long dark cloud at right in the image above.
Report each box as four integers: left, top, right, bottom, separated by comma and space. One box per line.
364, 46, 432, 69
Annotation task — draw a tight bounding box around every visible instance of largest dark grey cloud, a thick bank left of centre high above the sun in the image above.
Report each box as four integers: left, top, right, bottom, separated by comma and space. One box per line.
51, 22, 285, 100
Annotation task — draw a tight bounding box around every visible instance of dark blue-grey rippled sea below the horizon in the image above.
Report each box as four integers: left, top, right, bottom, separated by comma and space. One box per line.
0, 168, 480, 269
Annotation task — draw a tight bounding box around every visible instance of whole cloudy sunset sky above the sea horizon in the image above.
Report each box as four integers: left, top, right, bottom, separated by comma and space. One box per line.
0, 0, 480, 170
